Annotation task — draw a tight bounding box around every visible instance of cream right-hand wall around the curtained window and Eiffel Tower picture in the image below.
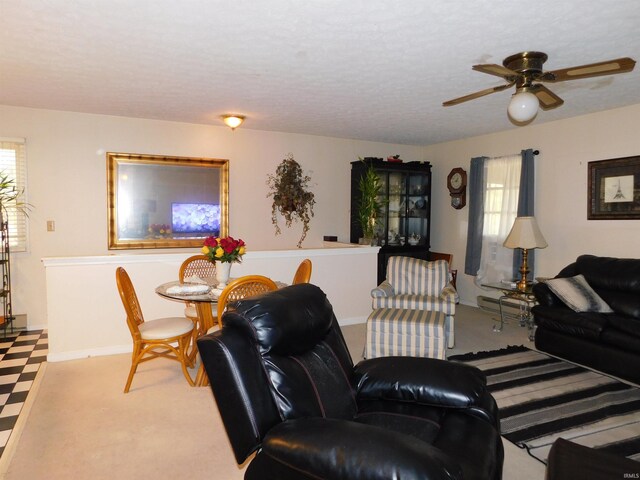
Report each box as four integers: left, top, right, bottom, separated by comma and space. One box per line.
424, 105, 640, 304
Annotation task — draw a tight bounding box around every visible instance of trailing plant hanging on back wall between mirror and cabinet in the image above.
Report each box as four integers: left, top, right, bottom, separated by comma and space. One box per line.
267, 153, 316, 248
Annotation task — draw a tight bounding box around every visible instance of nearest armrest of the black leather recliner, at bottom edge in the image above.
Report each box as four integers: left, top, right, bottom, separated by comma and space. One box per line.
252, 418, 463, 480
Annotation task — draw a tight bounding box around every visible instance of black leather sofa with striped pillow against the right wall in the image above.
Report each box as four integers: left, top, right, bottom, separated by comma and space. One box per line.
531, 255, 640, 383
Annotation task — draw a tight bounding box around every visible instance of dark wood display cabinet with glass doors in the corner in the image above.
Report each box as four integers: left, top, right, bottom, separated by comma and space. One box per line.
350, 158, 431, 283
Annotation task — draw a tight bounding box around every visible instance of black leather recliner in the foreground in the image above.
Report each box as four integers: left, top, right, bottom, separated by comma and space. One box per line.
198, 284, 503, 480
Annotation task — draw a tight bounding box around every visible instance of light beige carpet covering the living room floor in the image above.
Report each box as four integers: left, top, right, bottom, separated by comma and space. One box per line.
4, 305, 544, 480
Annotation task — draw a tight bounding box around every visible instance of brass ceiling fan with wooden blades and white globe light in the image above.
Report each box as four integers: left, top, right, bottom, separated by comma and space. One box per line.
442, 52, 636, 123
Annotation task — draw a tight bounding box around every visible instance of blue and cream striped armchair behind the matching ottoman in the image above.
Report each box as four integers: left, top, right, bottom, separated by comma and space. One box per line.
371, 256, 459, 348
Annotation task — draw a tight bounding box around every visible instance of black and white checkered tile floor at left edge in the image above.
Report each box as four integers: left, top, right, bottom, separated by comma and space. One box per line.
0, 330, 48, 456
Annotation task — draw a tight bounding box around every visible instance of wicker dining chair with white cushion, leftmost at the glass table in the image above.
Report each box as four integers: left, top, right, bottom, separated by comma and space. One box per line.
116, 267, 194, 393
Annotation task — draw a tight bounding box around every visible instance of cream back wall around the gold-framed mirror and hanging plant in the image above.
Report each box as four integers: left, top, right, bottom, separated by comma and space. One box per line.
0, 106, 422, 327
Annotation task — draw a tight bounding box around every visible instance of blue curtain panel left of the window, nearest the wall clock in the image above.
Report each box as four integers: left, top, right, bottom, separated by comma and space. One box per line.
464, 157, 488, 276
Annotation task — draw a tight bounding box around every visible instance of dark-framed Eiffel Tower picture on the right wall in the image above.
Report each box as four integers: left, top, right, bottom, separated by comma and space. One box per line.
587, 156, 640, 220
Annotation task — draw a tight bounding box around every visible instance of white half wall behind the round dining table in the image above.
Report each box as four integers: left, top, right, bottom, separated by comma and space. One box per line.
43, 243, 378, 362
